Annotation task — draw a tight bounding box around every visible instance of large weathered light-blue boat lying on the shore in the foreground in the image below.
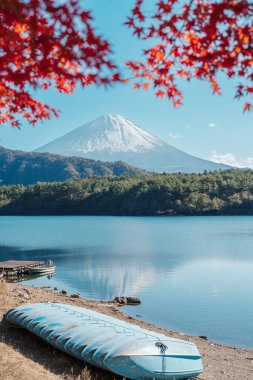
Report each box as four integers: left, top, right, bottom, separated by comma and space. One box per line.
5, 303, 203, 380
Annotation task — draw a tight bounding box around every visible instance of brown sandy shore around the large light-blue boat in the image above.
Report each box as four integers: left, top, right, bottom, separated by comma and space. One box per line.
0, 282, 253, 380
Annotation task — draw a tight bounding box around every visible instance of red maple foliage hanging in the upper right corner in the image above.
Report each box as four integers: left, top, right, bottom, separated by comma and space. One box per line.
126, 0, 253, 111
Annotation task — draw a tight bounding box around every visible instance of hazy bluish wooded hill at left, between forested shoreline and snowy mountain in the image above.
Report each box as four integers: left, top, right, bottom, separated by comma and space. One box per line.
0, 147, 143, 185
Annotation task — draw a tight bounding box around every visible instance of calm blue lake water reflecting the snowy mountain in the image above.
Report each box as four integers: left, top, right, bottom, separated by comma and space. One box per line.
0, 216, 253, 348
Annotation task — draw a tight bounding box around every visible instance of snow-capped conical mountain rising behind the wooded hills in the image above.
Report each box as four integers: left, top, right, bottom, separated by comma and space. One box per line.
36, 114, 229, 172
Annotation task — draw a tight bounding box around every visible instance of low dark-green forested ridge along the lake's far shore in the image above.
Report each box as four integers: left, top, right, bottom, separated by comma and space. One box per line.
0, 170, 253, 215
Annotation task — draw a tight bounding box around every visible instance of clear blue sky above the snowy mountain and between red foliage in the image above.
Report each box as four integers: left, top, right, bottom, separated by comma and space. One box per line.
0, 0, 253, 167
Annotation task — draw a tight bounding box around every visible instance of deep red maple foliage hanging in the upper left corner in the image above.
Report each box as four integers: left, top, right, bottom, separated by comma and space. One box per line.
0, 0, 120, 126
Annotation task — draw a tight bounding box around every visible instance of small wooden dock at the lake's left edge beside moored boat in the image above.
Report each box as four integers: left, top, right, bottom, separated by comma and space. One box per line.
0, 260, 44, 277
